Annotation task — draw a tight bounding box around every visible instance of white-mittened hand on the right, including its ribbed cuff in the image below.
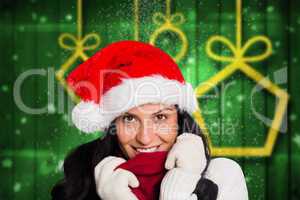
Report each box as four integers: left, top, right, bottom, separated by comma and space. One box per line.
159, 133, 207, 200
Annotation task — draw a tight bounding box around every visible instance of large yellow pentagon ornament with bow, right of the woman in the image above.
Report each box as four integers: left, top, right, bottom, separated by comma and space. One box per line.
193, 0, 289, 157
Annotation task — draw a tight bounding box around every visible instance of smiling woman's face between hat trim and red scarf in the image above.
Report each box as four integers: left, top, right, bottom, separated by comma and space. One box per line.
116, 104, 178, 159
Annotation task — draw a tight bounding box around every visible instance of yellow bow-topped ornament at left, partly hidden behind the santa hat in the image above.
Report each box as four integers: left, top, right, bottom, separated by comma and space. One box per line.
55, 0, 101, 102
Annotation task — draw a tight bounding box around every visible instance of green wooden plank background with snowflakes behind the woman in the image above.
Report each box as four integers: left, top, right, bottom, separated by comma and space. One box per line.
0, 0, 300, 200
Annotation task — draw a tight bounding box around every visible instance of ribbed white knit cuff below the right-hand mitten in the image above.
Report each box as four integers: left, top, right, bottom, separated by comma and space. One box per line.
159, 168, 201, 200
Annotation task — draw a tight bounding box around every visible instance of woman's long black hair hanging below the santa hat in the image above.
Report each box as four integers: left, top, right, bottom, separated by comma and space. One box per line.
51, 106, 218, 200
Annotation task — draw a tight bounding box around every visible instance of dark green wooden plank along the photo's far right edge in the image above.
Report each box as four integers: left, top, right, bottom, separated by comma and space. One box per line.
286, 0, 300, 199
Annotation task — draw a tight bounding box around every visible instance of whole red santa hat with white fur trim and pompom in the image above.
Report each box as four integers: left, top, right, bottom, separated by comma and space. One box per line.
67, 41, 198, 133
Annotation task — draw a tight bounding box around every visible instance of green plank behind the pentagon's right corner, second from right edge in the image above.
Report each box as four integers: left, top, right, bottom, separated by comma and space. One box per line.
266, 0, 290, 200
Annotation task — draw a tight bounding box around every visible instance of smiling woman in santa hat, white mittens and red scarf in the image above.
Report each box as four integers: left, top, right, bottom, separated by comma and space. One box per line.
52, 41, 248, 200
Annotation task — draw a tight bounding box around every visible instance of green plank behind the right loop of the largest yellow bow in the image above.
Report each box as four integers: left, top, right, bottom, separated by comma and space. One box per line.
241, 1, 268, 199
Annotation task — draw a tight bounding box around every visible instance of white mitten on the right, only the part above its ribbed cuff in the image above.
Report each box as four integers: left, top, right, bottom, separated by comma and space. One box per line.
165, 133, 207, 173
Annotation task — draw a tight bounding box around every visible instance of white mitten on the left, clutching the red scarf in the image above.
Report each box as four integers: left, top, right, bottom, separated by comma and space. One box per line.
94, 156, 139, 200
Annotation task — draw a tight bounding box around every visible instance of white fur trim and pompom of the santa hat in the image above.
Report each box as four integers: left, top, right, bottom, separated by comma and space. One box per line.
72, 75, 198, 133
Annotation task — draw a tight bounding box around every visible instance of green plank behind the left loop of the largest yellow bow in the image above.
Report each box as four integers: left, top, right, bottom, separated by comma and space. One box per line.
196, 0, 222, 146
